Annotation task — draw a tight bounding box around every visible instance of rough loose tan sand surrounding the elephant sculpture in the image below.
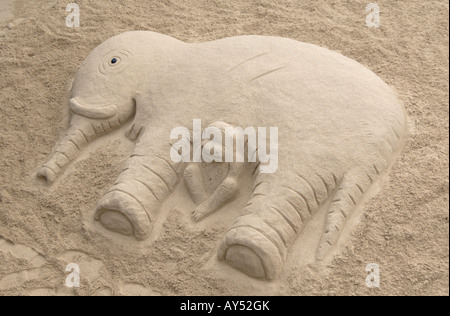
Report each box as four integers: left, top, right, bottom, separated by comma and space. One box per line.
0, 0, 449, 295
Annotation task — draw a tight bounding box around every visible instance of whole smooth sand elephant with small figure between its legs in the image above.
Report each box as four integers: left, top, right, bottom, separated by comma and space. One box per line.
39, 32, 406, 280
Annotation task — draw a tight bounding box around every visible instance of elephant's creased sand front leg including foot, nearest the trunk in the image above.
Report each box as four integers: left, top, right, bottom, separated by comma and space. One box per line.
95, 141, 183, 240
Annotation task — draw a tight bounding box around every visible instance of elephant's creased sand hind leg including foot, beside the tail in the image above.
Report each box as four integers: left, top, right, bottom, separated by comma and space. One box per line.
218, 170, 334, 280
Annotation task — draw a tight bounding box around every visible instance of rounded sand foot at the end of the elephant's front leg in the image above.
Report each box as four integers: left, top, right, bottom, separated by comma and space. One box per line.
95, 191, 152, 240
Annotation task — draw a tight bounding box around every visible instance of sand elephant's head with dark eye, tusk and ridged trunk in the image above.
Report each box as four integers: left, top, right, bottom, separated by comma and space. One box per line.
38, 32, 176, 182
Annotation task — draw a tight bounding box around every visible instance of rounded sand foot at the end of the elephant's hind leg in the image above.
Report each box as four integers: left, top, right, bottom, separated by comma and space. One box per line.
218, 227, 283, 280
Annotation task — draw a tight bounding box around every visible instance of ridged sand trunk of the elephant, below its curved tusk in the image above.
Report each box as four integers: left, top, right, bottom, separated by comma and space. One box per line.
38, 115, 122, 183
